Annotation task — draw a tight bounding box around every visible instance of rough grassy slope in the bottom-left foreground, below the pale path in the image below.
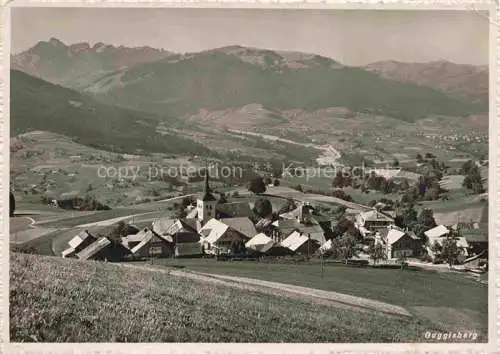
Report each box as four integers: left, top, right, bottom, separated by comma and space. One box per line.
10, 253, 434, 342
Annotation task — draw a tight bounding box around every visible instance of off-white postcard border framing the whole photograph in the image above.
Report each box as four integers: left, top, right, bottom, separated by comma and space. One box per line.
0, 0, 500, 354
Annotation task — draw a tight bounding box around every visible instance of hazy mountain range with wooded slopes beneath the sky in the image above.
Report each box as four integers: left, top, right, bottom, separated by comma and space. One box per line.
11, 38, 488, 153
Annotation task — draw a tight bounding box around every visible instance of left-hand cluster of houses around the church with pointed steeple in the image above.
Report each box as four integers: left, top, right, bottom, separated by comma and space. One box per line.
62, 174, 331, 260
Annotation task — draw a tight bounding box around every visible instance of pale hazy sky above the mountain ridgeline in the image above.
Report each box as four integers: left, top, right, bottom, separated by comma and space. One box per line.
11, 7, 490, 65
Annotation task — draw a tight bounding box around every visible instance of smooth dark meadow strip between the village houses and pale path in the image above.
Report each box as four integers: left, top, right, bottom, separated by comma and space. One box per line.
157, 259, 488, 320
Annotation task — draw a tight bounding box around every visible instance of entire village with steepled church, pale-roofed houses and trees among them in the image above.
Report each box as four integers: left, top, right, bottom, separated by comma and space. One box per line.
57, 170, 488, 274
